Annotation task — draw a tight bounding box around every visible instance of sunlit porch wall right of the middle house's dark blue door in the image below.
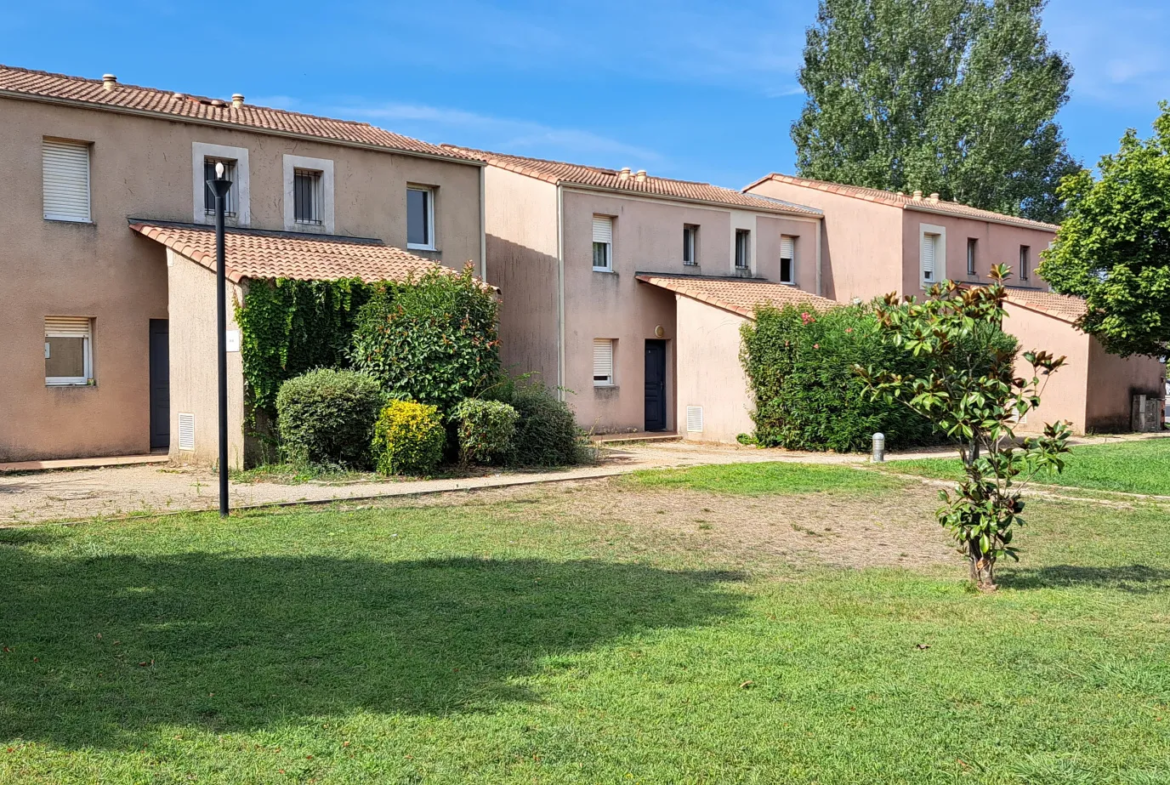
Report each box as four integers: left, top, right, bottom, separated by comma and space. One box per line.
675, 295, 755, 442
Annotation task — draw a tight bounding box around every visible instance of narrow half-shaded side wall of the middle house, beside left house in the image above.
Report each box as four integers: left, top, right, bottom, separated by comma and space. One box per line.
484, 166, 559, 387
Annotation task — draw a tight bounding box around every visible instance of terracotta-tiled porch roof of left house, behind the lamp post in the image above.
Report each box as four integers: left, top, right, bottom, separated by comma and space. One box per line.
130, 220, 454, 283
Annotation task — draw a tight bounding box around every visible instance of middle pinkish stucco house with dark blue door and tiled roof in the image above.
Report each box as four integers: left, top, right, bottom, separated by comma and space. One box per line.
464, 151, 821, 440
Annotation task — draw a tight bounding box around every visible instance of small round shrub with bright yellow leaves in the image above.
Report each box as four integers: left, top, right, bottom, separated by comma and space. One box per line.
373, 400, 447, 476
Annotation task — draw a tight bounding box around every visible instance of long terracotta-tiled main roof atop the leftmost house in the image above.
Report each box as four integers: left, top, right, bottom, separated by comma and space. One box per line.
0, 66, 475, 163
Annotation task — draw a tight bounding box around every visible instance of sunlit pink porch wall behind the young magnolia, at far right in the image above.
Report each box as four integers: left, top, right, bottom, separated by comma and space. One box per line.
1004, 303, 1089, 434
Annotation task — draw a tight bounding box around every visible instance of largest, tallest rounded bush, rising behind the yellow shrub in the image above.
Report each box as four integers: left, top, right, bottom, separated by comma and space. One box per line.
350, 266, 500, 414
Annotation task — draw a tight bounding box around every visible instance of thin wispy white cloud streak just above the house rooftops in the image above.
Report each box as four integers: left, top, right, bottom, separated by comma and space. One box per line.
333, 103, 663, 166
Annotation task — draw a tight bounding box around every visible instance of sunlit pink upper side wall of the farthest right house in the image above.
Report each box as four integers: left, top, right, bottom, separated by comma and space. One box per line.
749, 180, 902, 303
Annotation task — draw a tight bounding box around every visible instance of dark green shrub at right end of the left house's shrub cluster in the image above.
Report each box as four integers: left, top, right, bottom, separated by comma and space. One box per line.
509, 384, 586, 467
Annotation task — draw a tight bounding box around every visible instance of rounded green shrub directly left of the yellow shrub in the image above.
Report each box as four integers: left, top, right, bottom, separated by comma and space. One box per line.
276, 369, 381, 468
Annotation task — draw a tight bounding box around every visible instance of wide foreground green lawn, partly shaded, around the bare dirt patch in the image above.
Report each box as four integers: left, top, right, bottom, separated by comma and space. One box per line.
0, 464, 1170, 785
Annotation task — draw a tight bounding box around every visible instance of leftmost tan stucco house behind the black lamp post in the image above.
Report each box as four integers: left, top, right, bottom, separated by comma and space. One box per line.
0, 67, 484, 462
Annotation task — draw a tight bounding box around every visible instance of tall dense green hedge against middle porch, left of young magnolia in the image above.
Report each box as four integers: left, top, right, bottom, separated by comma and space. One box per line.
741, 304, 941, 453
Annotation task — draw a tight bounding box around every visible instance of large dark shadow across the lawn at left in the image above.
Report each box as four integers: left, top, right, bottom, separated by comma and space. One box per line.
0, 547, 741, 749
